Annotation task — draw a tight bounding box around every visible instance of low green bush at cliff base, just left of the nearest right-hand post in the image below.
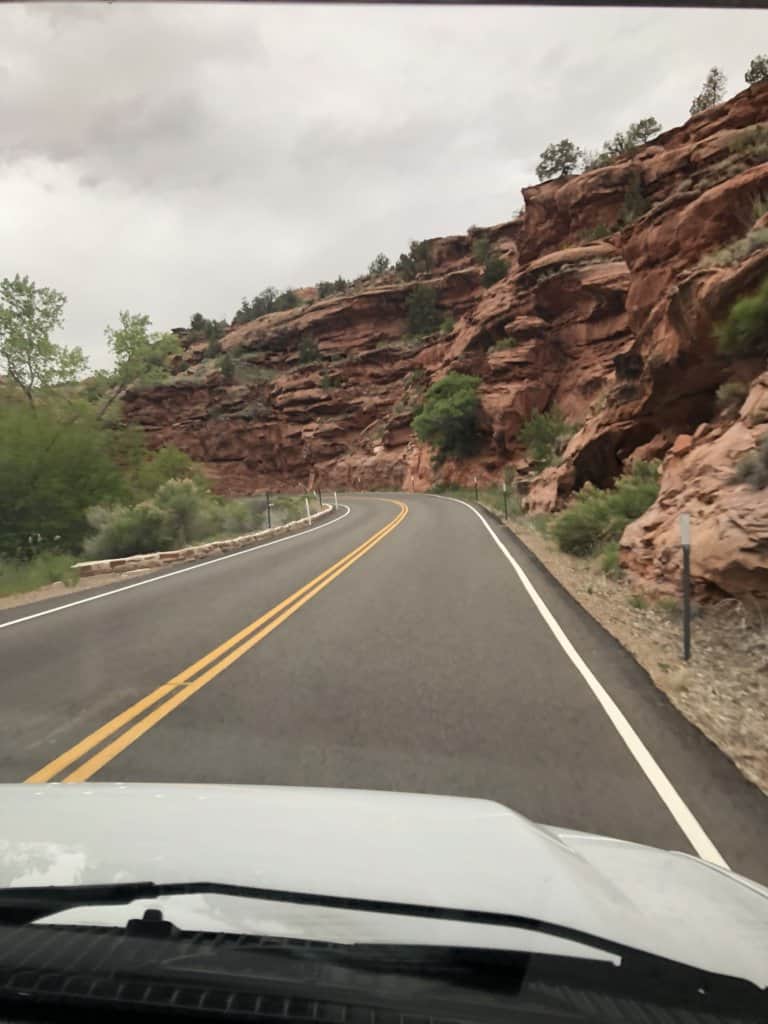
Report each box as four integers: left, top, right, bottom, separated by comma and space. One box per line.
552, 462, 658, 555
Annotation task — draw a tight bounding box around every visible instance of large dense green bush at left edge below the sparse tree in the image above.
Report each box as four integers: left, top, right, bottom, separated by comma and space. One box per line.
0, 401, 121, 558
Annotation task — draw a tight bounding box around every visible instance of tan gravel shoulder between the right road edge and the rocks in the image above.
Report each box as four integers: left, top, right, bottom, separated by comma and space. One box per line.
507, 518, 768, 796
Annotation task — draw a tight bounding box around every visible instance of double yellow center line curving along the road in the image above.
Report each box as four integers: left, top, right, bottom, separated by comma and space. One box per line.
26, 499, 408, 782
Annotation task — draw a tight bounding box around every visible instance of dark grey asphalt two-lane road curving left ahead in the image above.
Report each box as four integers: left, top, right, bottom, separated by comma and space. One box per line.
0, 495, 768, 883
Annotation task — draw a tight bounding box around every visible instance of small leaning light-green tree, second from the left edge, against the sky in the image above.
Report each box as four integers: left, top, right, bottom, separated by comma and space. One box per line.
98, 309, 181, 417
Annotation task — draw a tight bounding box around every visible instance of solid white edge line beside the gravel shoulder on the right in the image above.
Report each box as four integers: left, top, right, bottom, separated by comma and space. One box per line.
433, 495, 728, 868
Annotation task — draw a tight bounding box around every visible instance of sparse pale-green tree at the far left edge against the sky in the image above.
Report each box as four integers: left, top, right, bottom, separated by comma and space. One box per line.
0, 274, 88, 404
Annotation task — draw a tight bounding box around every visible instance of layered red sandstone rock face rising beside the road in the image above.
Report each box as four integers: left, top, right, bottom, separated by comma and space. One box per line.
125, 83, 768, 593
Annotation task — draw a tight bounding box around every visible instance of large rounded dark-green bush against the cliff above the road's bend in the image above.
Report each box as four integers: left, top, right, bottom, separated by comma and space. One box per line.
411, 373, 480, 456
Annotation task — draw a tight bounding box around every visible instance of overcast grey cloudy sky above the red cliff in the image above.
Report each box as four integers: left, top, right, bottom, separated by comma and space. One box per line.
0, 4, 766, 366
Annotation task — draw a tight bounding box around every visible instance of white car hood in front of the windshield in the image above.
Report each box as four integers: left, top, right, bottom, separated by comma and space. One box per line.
0, 783, 768, 987
